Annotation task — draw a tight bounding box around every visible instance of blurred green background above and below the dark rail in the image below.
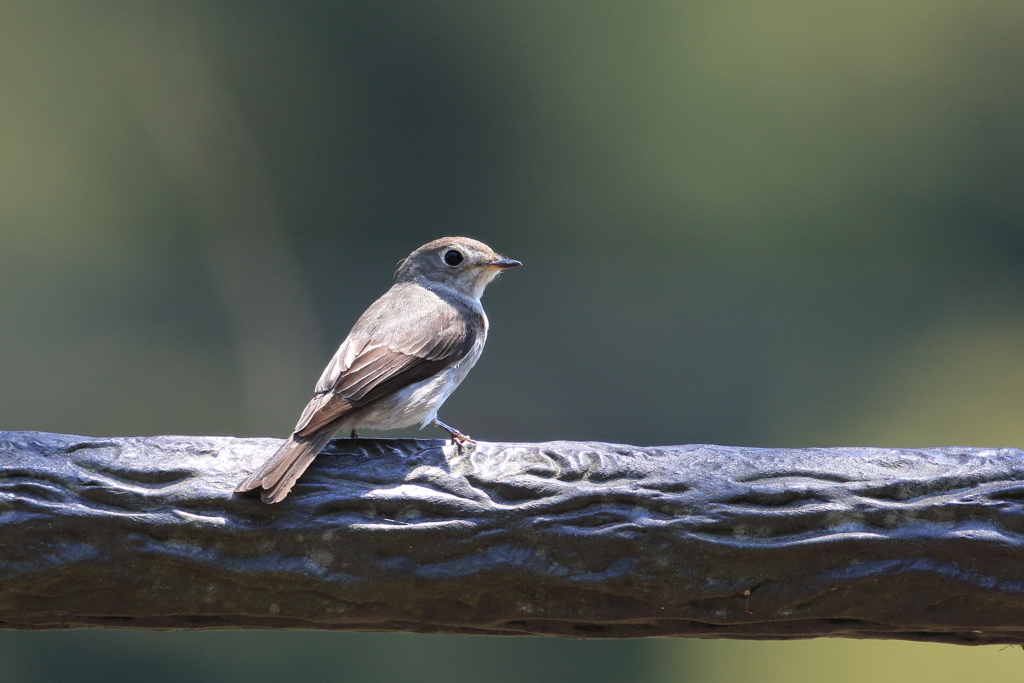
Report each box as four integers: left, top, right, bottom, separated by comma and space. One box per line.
0, 0, 1024, 683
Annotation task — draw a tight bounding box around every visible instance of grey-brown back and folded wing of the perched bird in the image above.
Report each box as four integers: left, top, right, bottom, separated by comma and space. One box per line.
295, 285, 476, 437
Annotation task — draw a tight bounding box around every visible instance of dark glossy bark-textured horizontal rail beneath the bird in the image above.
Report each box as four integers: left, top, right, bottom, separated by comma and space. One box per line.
0, 432, 1024, 644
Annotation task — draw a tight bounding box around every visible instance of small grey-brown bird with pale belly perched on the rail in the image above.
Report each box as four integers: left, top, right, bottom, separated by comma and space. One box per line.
234, 237, 522, 503
